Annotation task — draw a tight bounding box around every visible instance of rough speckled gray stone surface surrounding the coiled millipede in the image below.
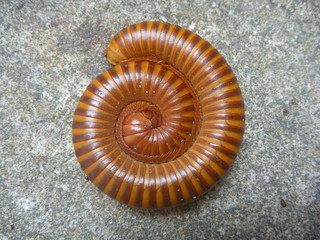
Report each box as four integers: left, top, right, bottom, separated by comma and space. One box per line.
0, 0, 320, 240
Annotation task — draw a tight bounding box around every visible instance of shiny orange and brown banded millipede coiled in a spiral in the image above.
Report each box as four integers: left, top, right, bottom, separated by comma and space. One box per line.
72, 22, 244, 208
